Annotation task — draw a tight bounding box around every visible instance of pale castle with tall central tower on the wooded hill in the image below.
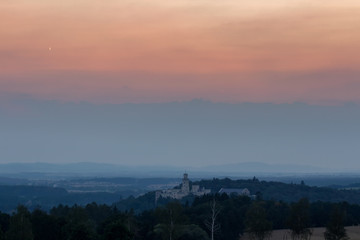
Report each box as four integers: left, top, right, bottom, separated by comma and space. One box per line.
155, 173, 211, 202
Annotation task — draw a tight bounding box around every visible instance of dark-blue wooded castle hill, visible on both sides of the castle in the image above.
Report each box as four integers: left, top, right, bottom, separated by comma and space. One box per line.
114, 177, 360, 213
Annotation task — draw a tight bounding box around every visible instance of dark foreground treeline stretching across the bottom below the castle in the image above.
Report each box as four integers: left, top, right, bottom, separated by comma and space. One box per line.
0, 194, 360, 240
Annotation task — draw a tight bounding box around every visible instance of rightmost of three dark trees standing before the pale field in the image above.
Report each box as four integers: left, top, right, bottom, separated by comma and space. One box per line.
324, 206, 349, 240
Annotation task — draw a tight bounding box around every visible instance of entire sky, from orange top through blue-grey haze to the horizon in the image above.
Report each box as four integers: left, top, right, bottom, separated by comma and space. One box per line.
0, 0, 360, 169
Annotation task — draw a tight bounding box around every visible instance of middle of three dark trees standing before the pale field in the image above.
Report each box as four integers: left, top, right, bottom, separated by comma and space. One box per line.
289, 198, 312, 240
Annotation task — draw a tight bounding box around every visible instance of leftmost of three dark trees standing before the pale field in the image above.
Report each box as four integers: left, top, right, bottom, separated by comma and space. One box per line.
245, 202, 272, 240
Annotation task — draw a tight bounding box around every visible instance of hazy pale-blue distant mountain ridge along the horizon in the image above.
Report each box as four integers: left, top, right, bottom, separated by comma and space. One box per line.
0, 162, 338, 177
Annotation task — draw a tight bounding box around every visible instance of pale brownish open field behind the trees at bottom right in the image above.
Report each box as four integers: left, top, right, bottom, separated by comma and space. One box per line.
241, 226, 360, 240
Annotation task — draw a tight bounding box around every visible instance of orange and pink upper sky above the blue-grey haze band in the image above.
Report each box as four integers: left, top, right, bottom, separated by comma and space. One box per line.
0, 0, 360, 103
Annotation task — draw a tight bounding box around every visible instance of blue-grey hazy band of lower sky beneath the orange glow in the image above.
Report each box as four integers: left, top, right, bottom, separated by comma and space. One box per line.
0, 96, 360, 172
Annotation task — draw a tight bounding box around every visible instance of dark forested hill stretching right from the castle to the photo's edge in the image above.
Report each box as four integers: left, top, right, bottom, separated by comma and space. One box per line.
194, 177, 360, 204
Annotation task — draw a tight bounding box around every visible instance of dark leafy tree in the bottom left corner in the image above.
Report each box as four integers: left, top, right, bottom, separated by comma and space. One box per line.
6, 206, 34, 240
